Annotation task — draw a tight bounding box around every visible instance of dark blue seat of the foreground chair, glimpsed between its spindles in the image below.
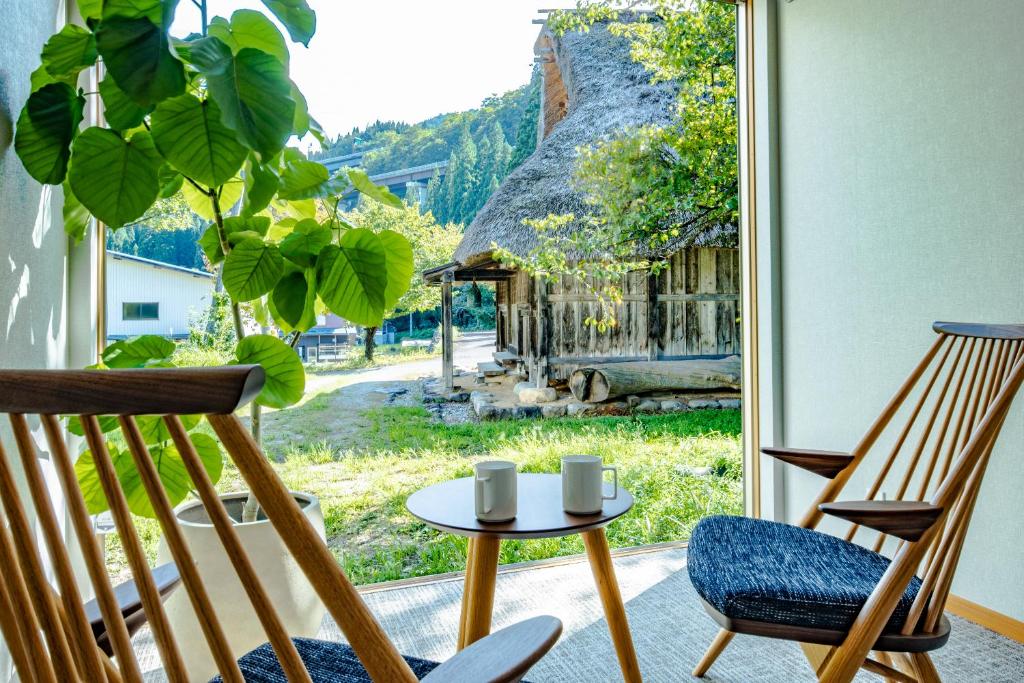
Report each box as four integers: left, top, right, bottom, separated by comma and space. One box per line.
210, 638, 438, 683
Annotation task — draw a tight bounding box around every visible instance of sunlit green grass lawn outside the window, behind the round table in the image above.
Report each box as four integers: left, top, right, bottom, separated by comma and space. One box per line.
109, 399, 742, 584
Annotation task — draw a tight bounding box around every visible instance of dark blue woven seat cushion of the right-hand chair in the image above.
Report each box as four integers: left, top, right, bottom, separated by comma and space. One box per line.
687, 516, 921, 632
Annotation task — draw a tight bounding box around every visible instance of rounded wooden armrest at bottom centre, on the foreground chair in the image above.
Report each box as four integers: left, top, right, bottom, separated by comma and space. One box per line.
422, 616, 562, 683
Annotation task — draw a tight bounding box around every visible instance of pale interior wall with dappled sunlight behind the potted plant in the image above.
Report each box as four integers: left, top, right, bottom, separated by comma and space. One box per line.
0, 0, 98, 680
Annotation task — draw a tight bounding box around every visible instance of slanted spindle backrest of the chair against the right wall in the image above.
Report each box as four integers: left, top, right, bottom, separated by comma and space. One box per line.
801, 323, 1024, 634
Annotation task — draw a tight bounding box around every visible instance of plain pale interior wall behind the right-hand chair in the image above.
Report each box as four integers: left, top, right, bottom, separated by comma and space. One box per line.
770, 0, 1024, 620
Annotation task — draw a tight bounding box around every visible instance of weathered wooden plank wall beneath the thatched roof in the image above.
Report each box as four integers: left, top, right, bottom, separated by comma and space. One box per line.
497, 248, 740, 377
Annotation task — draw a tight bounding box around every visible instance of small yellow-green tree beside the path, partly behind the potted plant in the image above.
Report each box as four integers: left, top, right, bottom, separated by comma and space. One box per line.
345, 202, 462, 360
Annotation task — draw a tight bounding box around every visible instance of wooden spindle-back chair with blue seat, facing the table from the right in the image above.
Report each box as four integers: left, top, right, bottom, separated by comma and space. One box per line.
688, 323, 1024, 683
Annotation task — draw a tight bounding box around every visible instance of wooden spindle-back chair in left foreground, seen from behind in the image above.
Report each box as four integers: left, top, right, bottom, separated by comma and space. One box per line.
0, 366, 561, 683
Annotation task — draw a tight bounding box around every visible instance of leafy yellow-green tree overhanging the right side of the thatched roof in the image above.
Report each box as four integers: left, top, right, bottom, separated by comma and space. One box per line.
499, 0, 738, 330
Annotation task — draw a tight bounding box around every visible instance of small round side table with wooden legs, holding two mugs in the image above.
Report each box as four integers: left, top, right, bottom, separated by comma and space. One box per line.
406, 474, 641, 683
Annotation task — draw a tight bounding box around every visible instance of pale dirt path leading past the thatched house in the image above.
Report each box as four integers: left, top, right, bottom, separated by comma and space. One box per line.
263, 332, 495, 452
